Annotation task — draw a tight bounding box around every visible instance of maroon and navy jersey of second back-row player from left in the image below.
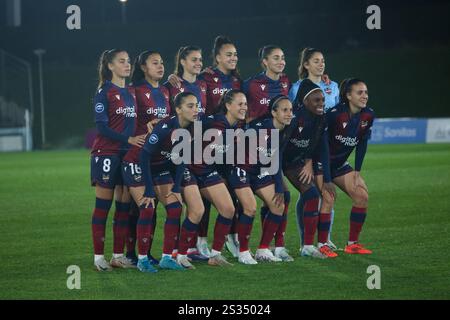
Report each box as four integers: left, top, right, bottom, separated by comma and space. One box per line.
124, 80, 170, 163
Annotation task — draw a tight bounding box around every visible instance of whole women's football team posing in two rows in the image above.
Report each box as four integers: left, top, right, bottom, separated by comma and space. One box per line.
90, 36, 375, 273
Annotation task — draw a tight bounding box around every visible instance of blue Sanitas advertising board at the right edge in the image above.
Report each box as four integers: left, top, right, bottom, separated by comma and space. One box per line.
369, 118, 450, 144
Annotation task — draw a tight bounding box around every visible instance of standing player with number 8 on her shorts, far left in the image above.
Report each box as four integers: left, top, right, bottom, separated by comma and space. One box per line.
91, 49, 145, 271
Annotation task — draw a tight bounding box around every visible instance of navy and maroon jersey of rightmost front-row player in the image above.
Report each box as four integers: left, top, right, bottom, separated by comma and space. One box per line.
325, 103, 375, 167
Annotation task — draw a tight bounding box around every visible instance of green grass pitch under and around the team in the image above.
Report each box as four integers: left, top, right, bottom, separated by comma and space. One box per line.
0, 144, 450, 300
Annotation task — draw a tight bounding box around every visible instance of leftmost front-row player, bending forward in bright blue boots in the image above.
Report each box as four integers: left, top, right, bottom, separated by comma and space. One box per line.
138, 92, 198, 270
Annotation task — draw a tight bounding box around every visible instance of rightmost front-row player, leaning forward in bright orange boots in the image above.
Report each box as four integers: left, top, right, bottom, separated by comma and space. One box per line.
316, 78, 375, 254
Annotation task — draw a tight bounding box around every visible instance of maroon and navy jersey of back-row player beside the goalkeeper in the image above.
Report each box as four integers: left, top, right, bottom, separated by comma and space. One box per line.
243, 72, 291, 119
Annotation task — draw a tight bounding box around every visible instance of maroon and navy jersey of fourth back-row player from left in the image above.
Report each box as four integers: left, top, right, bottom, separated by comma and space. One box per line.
199, 68, 241, 116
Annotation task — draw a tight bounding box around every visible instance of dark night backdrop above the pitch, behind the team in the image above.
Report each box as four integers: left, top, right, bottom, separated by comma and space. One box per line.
0, 0, 450, 148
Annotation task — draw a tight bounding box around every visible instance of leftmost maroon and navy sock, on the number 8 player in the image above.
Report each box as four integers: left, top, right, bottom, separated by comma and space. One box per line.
91, 198, 112, 255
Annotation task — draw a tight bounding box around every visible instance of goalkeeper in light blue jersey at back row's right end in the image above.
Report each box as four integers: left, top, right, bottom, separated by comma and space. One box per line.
289, 48, 339, 250
